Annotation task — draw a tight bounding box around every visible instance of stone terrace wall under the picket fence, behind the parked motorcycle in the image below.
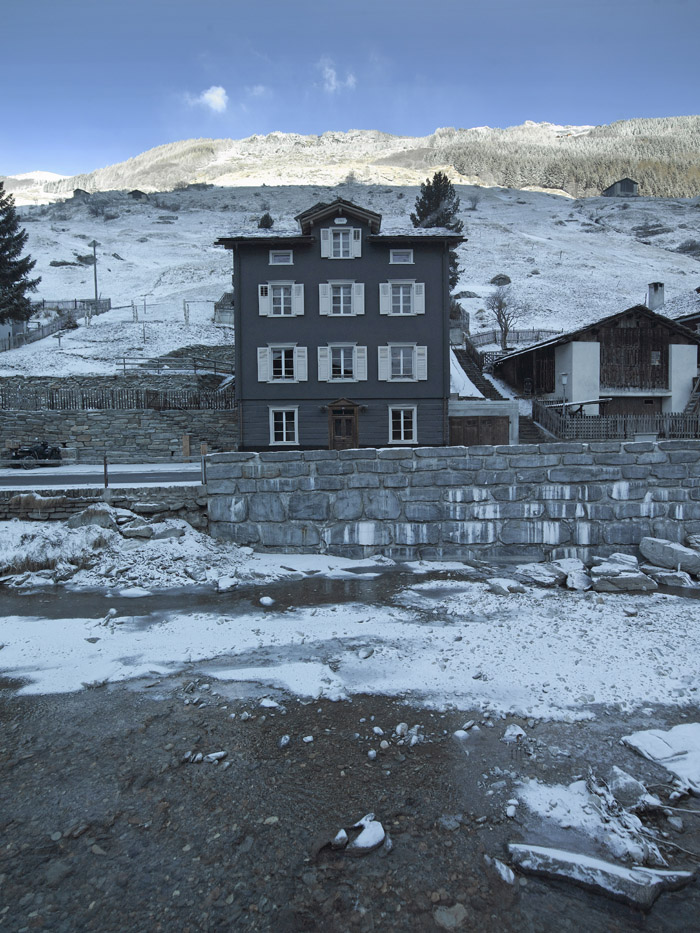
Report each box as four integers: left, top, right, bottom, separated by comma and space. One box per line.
0, 409, 238, 463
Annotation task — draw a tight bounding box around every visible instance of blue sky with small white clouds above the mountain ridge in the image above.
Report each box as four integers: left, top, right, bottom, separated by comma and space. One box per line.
0, 0, 700, 175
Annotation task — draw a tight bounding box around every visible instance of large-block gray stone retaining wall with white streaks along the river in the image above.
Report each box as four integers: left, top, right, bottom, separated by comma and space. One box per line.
207, 440, 700, 561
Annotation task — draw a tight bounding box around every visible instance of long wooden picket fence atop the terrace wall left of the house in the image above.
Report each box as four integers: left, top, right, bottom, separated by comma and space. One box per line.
0, 387, 236, 411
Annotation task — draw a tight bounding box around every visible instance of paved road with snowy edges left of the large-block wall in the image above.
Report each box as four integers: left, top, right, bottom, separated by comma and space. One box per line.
0, 463, 202, 489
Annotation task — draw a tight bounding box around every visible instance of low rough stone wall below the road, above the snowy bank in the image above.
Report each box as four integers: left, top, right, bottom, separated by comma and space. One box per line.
0, 486, 208, 531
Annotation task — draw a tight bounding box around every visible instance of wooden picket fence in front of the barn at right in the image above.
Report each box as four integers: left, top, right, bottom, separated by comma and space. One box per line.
532, 399, 700, 441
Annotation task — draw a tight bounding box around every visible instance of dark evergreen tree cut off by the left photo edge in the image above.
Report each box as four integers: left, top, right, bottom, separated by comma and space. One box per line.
0, 182, 41, 324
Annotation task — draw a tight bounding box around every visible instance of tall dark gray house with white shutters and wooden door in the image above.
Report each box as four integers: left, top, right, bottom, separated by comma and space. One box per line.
216, 198, 463, 450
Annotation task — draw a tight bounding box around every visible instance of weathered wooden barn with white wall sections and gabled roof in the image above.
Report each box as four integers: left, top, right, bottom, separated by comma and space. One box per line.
494, 305, 700, 415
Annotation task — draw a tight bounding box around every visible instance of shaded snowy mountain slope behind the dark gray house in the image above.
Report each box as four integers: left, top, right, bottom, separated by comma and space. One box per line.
0, 177, 700, 375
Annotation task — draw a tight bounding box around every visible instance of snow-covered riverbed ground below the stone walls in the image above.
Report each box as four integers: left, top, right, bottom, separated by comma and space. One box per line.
0, 508, 700, 721
